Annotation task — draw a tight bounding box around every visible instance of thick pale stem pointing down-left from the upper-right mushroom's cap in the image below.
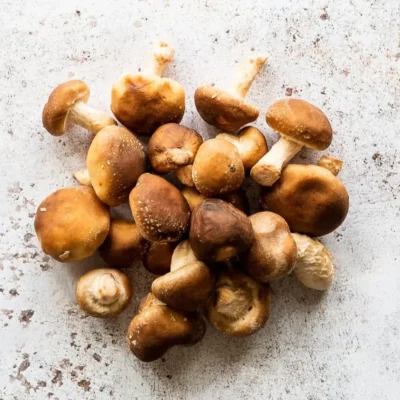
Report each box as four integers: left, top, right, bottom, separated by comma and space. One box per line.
250, 136, 303, 186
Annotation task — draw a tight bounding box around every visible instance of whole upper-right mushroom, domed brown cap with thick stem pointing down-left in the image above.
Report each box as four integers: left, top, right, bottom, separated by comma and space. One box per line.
251, 99, 332, 186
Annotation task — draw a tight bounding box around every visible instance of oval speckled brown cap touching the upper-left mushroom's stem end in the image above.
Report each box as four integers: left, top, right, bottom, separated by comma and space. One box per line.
86, 126, 147, 207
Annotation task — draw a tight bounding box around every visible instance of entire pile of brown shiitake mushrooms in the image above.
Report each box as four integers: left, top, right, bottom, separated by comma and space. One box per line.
35, 42, 349, 362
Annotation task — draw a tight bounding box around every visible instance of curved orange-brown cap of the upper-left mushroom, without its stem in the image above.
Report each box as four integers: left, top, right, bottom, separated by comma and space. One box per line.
42, 80, 90, 136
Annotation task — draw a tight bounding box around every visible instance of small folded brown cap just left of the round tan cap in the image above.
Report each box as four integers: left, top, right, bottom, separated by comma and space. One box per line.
147, 123, 203, 174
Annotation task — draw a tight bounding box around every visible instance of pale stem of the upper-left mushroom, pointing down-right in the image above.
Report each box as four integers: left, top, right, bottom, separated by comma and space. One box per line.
67, 101, 117, 134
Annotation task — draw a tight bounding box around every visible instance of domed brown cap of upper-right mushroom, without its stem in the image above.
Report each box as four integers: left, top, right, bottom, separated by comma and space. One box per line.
267, 99, 332, 150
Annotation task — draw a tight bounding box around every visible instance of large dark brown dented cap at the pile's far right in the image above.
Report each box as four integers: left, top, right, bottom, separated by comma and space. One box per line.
260, 164, 349, 236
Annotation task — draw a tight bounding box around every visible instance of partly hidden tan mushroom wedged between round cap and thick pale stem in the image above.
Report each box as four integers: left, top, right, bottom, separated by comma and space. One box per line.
215, 126, 268, 171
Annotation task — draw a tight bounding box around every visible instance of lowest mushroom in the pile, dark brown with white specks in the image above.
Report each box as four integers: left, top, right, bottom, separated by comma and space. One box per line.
127, 294, 206, 362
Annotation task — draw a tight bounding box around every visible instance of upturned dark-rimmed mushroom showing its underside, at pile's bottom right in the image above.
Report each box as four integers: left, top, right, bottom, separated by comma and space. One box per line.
205, 270, 271, 336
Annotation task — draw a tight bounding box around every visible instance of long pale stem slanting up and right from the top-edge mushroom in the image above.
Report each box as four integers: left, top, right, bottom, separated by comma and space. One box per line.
228, 56, 267, 99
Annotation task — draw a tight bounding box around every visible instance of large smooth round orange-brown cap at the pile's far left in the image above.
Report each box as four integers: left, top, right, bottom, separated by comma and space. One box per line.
35, 186, 110, 262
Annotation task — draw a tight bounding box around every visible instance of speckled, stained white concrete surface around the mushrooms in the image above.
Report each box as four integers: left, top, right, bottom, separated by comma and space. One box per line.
0, 0, 400, 400
